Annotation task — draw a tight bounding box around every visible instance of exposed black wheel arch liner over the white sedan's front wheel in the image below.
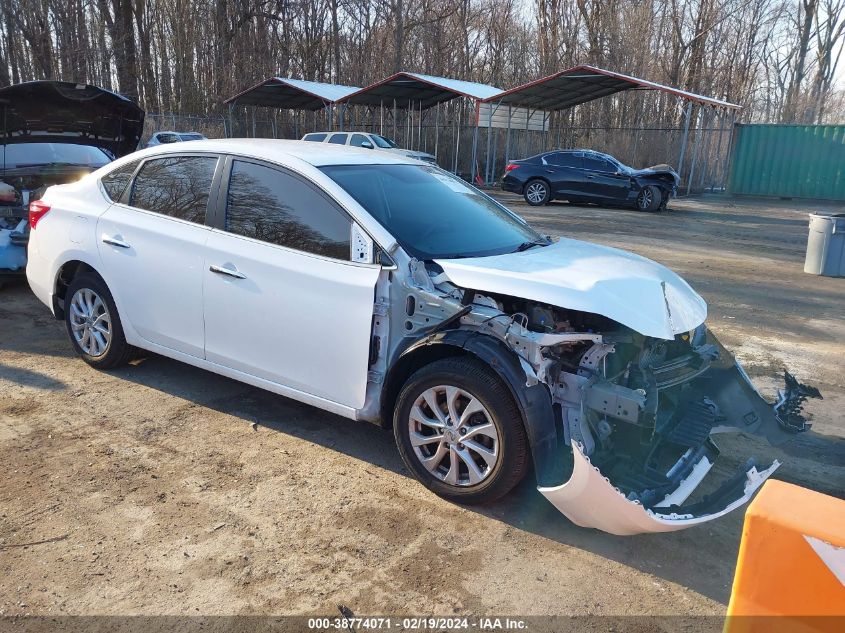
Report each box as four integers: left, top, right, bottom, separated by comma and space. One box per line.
381, 330, 563, 486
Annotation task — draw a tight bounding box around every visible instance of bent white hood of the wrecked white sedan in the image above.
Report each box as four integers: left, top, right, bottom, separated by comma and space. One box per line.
436, 238, 707, 339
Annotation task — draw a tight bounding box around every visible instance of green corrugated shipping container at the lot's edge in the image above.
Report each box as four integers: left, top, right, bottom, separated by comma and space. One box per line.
728, 124, 845, 200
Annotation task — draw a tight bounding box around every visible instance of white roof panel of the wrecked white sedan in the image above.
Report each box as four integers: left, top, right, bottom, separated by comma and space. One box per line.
133, 138, 421, 167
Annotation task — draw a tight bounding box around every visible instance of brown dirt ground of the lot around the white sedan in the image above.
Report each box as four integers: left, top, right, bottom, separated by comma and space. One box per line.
0, 196, 845, 616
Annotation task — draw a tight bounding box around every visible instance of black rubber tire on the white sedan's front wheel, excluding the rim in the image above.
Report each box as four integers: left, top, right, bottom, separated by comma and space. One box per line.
393, 357, 529, 504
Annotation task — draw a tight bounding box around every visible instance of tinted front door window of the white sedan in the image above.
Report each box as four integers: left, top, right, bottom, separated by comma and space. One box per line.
226, 160, 352, 260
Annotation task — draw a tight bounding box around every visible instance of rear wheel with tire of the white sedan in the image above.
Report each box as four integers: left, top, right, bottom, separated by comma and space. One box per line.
65, 273, 134, 369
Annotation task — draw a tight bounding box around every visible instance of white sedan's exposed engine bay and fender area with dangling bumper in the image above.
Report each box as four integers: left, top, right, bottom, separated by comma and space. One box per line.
388, 262, 821, 535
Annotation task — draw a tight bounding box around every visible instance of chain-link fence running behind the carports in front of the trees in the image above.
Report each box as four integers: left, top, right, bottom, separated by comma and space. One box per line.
141, 108, 733, 194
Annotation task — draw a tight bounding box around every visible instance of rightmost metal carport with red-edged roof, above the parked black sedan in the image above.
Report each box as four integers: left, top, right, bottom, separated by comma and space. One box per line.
476, 65, 742, 191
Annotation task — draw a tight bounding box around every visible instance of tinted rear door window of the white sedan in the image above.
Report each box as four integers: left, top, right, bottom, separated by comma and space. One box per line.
129, 156, 217, 224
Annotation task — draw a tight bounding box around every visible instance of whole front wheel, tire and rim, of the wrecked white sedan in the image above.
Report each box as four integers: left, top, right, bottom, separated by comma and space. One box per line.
394, 358, 528, 503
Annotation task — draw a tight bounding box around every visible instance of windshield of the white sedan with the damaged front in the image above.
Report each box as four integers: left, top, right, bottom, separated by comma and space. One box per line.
322, 165, 545, 259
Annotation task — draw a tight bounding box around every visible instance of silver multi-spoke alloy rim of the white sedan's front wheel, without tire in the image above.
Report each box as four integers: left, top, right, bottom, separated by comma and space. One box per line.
408, 385, 500, 487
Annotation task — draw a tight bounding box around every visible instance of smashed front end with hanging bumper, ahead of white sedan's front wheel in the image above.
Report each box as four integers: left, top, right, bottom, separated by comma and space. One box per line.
524, 326, 820, 535
